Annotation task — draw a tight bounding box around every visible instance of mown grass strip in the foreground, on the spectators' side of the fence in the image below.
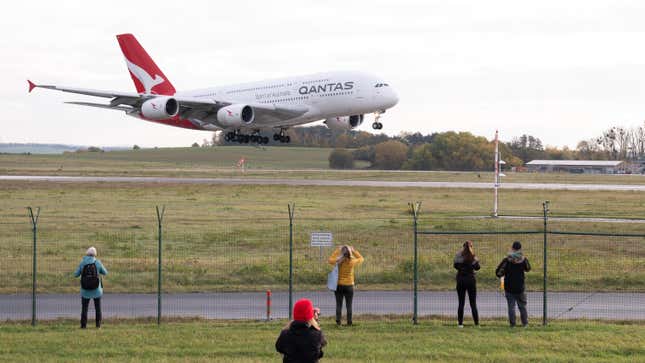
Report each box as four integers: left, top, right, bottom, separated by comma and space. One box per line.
0, 318, 645, 362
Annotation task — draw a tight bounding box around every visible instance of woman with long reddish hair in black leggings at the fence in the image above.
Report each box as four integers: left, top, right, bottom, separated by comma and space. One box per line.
453, 241, 480, 328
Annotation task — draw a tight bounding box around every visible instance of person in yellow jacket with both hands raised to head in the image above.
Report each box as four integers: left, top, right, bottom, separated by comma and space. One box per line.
328, 245, 363, 325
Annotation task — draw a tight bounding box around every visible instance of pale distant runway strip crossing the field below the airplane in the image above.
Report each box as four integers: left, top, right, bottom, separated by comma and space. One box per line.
0, 175, 645, 192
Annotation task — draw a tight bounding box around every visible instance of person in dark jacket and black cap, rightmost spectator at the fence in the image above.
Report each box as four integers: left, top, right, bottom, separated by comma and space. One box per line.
495, 241, 531, 327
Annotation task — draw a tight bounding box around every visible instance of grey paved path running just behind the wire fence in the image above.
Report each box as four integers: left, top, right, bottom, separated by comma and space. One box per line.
0, 291, 645, 321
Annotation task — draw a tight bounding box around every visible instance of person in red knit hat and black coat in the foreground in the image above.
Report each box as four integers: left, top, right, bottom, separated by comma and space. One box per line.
275, 299, 327, 363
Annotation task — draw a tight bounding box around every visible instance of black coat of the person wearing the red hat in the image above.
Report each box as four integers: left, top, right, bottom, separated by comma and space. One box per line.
275, 321, 327, 363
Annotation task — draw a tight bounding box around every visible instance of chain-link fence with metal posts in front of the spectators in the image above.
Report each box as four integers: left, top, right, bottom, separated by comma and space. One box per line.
0, 206, 645, 323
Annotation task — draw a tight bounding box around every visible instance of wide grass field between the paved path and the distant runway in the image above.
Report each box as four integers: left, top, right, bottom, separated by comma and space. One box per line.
0, 182, 645, 293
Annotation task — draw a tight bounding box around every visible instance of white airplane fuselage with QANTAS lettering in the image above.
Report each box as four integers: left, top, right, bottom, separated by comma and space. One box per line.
176, 72, 398, 129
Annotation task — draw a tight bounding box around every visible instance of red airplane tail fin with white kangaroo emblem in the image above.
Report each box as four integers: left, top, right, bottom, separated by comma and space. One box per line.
116, 34, 175, 96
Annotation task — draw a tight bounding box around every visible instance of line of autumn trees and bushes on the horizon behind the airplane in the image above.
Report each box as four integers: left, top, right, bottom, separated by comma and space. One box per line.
212, 123, 645, 170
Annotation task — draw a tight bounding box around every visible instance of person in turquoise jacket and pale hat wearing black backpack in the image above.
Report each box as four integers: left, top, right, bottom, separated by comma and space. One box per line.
74, 247, 107, 329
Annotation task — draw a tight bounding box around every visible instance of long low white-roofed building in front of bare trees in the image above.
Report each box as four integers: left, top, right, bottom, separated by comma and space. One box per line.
526, 160, 624, 174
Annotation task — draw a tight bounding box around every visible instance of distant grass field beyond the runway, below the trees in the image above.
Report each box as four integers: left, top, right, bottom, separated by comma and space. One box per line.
0, 146, 645, 185
